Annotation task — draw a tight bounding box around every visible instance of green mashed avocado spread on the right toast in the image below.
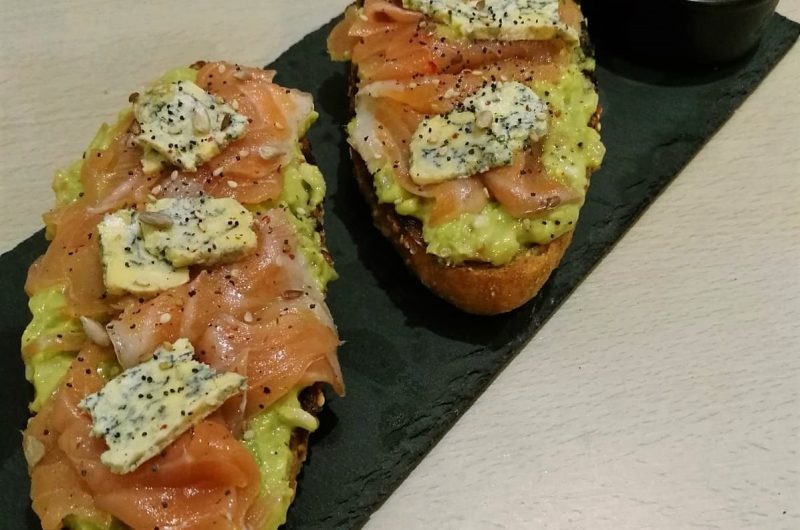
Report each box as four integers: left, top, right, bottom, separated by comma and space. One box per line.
348, 47, 605, 266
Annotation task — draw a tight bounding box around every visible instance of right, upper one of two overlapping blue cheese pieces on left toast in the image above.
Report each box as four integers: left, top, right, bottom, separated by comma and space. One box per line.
142, 196, 256, 267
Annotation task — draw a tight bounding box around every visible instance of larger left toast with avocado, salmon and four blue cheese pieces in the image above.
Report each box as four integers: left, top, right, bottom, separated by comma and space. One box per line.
22, 62, 344, 530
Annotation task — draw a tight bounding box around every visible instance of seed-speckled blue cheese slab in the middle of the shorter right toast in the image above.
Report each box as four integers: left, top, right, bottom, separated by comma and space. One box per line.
410, 81, 548, 185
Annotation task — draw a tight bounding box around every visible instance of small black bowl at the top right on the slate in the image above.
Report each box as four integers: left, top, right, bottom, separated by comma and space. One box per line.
582, 0, 778, 64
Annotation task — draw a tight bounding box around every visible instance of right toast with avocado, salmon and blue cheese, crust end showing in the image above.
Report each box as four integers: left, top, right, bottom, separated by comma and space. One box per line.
328, 0, 604, 314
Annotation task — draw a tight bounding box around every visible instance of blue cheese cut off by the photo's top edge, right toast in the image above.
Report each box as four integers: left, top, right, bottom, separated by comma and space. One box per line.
403, 0, 580, 41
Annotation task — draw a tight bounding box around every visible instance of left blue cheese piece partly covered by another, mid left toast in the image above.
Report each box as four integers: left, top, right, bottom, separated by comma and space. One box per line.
97, 210, 189, 296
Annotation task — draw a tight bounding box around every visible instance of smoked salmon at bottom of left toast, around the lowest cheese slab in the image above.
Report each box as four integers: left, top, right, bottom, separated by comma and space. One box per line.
25, 345, 260, 530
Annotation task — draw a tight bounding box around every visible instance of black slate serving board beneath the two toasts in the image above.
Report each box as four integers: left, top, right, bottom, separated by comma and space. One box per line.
0, 11, 800, 530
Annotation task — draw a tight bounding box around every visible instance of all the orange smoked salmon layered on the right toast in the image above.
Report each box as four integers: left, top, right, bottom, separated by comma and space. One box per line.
328, 0, 582, 225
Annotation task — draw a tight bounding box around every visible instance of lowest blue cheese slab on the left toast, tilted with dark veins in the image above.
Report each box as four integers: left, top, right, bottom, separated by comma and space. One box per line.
80, 339, 246, 474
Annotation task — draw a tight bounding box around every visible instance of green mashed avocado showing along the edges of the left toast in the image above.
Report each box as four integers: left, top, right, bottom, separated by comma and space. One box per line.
22, 68, 336, 530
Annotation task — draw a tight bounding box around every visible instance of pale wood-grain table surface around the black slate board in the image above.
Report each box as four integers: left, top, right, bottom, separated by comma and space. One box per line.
0, 0, 800, 530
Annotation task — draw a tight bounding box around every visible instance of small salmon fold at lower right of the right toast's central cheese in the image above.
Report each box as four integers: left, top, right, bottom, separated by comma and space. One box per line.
481, 143, 581, 219
